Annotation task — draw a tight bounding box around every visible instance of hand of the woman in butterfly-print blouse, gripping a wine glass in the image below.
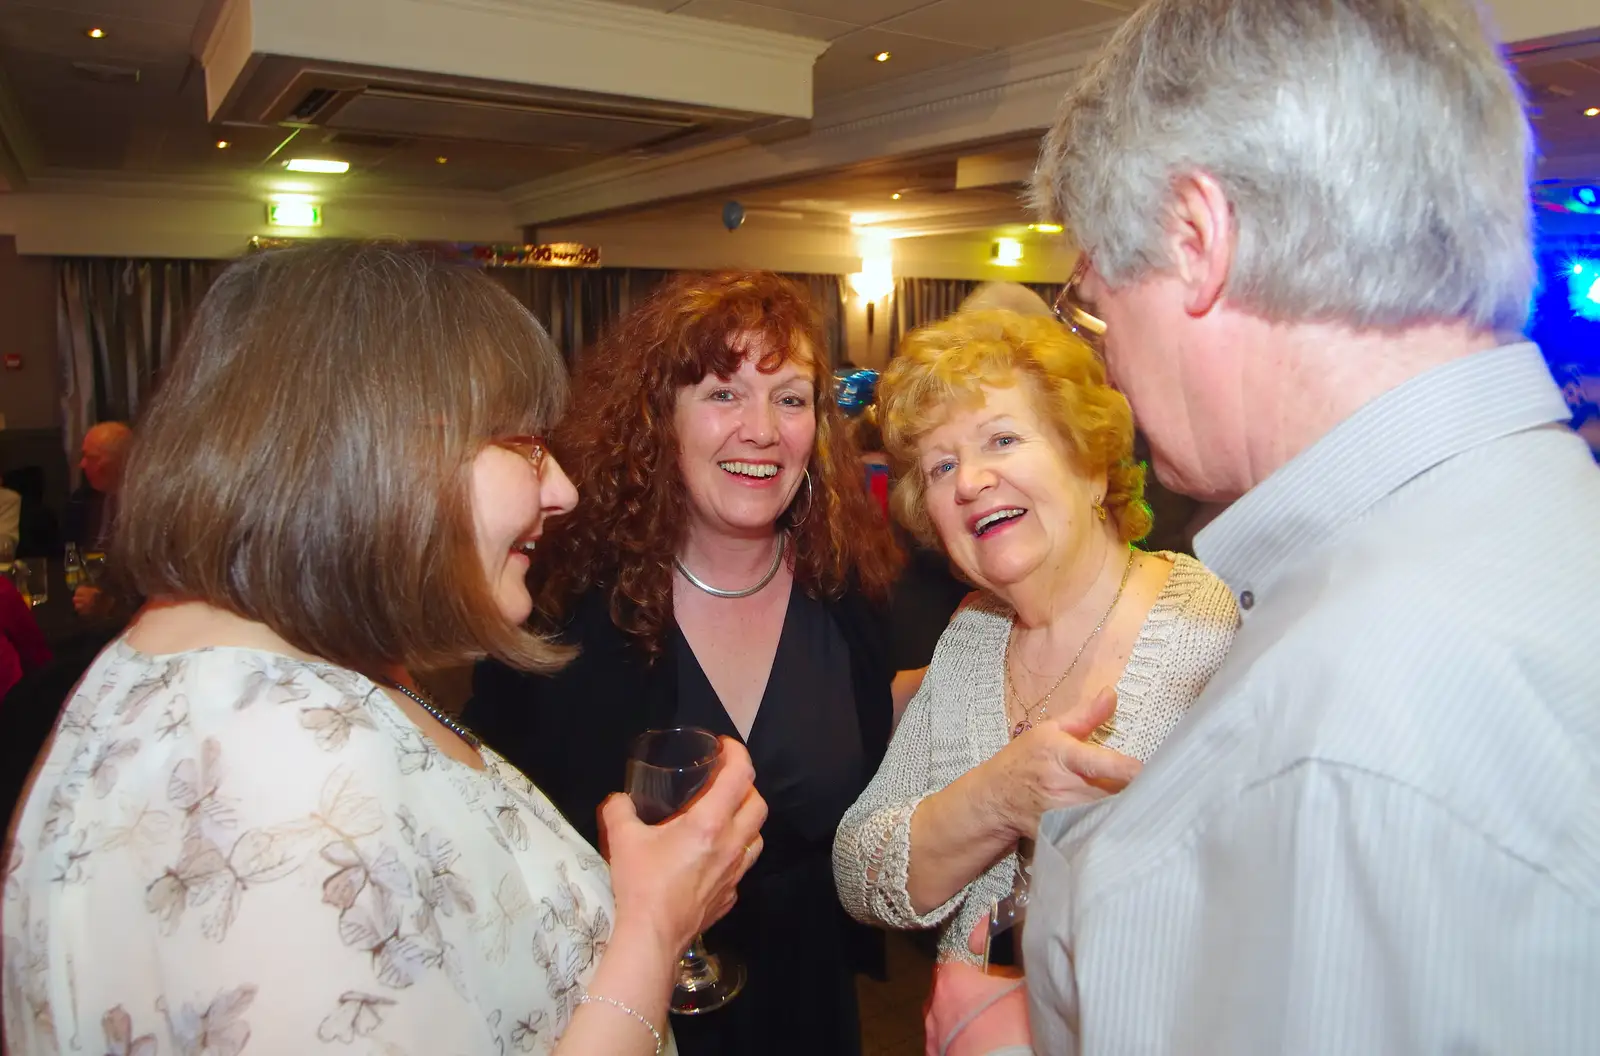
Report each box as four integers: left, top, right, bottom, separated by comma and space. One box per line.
600, 734, 766, 1000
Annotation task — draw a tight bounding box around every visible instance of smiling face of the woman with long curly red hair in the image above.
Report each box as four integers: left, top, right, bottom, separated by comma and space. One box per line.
675, 334, 816, 536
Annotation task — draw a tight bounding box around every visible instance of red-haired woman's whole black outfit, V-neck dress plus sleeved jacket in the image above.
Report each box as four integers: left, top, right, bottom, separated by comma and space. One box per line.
464, 587, 894, 1056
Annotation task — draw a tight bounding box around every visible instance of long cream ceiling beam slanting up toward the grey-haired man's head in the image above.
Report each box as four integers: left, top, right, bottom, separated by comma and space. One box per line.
507, 26, 1115, 224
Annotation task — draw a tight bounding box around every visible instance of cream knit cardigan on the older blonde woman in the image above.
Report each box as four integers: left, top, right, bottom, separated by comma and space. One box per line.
834, 554, 1238, 962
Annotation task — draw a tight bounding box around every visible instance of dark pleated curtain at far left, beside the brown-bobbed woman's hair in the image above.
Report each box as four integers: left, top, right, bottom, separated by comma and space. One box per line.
56, 258, 227, 485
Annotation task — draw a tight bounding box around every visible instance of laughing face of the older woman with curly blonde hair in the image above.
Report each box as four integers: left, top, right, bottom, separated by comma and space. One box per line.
917, 382, 1106, 597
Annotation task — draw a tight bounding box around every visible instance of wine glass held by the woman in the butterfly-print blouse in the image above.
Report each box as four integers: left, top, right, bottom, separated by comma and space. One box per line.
624, 726, 744, 1016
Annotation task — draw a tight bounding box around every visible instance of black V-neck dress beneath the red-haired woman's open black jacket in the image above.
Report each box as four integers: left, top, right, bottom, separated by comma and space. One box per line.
672, 589, 870, 1056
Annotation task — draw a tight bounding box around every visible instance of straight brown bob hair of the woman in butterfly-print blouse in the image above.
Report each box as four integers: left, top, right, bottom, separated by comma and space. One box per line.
114, 243, 582, 674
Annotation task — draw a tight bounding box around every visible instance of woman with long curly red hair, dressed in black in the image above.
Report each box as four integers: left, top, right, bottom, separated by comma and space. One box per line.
466, 272, 898, 1056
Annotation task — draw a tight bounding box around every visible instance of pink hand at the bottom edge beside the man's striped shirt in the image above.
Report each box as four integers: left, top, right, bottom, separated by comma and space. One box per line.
922, 920, 1032, 1056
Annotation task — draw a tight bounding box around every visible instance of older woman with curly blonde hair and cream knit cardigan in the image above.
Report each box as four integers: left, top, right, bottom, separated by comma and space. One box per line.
834, 310, 1238, 962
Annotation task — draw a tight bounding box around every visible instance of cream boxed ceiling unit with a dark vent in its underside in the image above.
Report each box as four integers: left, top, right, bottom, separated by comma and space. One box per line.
195, 0, 827, 155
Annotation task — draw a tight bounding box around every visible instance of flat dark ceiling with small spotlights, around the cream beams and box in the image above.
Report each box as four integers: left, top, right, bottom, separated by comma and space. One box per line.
0, 0, 1600, 234
